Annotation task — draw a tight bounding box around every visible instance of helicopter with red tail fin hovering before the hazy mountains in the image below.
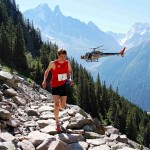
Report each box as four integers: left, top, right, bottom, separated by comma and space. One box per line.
81, 45, 126, 62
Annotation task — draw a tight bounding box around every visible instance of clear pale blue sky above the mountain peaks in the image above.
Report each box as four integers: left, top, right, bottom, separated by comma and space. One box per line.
16, 0, 150, 33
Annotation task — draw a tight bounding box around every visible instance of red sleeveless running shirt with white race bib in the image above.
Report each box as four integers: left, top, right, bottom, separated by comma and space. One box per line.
50, 60, 68, 87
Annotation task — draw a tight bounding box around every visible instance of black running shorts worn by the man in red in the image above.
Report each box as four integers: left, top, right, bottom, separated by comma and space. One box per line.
52, 83, 67, 96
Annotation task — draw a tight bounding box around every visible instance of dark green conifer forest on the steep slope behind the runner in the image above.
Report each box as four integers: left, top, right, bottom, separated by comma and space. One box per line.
0, 0, 150, 147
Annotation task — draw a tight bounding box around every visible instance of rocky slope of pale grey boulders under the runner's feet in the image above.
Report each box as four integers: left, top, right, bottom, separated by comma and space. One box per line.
0, 68, 148, 150
